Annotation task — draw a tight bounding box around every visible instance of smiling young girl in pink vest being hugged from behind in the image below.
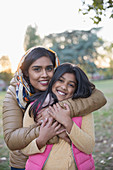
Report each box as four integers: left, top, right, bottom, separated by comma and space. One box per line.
23, 63, 95, 170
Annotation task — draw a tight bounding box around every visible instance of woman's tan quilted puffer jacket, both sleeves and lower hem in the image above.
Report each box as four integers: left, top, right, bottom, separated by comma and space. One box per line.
3, 75, 106, 168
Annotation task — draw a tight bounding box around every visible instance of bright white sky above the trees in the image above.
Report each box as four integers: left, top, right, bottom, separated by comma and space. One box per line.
0, 0, 113, 72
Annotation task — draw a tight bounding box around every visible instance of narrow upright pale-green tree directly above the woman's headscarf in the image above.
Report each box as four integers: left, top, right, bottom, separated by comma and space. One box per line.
24, 25, 41, 51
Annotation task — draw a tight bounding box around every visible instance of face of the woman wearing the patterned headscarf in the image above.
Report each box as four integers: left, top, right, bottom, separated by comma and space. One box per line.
28, 56, 54, 92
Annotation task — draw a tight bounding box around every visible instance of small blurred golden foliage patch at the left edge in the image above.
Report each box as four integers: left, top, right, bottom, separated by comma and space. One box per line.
0, 56, 11, 73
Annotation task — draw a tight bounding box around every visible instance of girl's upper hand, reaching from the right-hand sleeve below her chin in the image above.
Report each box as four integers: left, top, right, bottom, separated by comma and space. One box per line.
48, 103, 73, 133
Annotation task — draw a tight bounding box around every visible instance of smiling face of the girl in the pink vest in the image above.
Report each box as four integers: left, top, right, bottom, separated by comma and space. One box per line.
52, 73, 77, 101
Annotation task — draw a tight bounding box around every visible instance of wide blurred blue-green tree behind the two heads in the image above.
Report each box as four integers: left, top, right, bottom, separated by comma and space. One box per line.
44, 28, 103, 74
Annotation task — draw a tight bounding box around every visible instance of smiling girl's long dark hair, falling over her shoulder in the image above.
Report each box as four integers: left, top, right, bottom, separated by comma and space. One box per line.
30, 63, 95, 120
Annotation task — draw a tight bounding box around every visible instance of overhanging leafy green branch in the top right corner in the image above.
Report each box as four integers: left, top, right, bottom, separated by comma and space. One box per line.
79, 0, 113, 24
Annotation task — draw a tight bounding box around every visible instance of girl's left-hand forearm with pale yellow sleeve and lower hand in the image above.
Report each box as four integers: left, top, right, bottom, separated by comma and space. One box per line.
21, 116, 64, 156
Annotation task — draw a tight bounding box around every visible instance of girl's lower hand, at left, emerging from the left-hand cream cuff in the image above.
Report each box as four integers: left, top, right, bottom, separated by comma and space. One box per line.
36, 118, 65, 149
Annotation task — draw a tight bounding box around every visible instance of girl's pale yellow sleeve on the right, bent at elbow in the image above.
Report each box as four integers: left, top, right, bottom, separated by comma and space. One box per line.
67, 113, 95, 154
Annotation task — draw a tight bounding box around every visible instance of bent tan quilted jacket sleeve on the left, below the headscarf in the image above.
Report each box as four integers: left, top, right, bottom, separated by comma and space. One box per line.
3, 85, 39, 150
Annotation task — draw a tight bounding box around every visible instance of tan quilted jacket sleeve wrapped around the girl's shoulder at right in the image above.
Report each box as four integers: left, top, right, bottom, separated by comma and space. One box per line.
60, 89, 107, 117
